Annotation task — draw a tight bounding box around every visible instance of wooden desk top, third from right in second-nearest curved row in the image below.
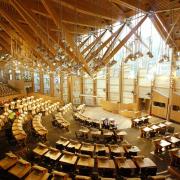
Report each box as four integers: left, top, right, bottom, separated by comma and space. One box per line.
97, 159, 115, 169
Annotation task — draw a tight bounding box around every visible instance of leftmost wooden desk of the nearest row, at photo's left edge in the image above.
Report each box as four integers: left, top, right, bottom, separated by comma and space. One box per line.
0, 153, 18, 170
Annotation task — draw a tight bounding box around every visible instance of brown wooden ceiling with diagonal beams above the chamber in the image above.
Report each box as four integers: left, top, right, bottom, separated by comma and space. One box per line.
0, 0, 180, 74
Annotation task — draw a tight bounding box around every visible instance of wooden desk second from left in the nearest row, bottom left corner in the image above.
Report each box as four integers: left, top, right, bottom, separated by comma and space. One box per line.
8, 159, 31, 178
